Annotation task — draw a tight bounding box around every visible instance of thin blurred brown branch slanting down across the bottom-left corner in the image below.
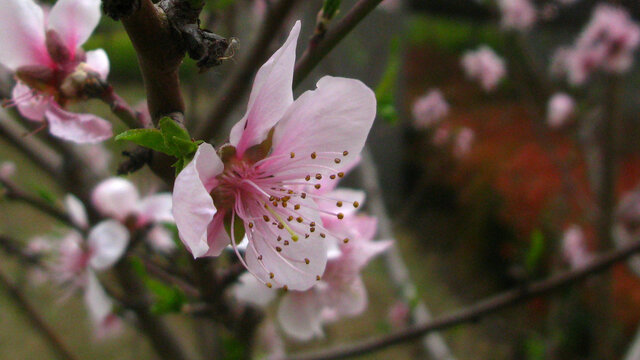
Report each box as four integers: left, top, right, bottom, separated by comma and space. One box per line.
0, 268, 78, 360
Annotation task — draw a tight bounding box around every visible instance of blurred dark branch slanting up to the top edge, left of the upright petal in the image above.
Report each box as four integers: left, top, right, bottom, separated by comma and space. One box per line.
194, 0, 296, 140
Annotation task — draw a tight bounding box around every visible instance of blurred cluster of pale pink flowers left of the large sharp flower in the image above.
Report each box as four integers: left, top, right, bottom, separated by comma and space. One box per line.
29, 178, 176, 337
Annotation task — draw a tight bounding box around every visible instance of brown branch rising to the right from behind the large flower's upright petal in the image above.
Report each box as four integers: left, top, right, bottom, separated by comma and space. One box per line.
293, 0, 382, 88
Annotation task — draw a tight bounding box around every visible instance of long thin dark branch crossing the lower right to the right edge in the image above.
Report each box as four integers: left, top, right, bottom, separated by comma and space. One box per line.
287, 241, 640, 360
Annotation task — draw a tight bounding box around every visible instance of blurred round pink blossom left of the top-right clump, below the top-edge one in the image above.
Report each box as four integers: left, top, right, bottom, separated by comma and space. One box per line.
462, 45, 506, 91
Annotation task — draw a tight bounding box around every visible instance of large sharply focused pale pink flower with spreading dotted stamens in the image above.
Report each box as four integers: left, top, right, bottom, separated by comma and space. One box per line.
173, 22, 376, 290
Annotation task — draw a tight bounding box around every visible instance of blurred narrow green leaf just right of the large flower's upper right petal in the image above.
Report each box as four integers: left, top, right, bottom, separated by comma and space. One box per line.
375, 38, 401, 125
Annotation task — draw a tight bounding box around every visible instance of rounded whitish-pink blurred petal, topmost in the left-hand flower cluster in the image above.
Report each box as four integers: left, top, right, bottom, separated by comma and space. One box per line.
91, 177, 140, 221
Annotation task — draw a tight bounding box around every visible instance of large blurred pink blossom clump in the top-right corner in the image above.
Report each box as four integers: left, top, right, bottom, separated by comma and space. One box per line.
552, 4, 640, 85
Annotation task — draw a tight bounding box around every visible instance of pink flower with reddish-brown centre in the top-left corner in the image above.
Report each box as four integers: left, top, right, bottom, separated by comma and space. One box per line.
0, 0, 112, 143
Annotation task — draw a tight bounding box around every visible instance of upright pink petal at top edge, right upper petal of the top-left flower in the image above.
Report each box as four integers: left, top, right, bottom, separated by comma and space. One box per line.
47, 0, 100, 54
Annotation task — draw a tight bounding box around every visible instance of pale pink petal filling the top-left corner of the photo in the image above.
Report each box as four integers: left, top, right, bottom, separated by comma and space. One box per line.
0, 0, 51, 70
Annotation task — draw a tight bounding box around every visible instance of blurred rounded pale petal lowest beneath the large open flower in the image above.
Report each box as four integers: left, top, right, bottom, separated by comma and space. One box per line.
278, 291, 323, 341
